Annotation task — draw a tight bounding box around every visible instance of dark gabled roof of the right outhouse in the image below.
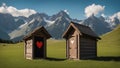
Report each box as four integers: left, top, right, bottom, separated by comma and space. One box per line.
62, 22, 100, 39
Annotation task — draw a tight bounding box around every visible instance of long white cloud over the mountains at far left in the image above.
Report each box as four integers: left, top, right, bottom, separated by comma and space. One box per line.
0, 3, 36, 17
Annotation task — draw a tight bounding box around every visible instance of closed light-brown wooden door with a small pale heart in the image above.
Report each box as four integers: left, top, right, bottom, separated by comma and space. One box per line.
69, 36, 78, 59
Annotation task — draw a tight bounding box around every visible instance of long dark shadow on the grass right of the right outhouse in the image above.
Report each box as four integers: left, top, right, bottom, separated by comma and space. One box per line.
92, 56, 120, 61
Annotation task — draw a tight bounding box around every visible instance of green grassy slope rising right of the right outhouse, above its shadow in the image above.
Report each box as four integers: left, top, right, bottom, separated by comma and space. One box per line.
98, 25, 120, 56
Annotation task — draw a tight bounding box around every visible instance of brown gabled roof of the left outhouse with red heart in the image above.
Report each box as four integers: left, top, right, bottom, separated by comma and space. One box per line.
23, 26, 51, 40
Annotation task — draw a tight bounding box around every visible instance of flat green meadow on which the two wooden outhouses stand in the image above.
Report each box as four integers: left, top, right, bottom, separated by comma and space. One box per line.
0, 40, 120, 68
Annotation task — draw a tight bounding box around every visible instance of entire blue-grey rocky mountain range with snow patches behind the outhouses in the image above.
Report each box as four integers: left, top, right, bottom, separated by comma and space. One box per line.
0, 10, 120, 41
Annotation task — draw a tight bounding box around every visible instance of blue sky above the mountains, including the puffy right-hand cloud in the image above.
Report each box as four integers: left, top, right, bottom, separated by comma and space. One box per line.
0, 0, 120, 20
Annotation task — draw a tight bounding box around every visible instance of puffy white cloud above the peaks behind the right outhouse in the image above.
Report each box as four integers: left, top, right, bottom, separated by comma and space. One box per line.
85, 4, 105, 17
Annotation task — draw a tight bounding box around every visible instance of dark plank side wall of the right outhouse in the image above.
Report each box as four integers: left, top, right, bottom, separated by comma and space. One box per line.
80, 37, 96, 59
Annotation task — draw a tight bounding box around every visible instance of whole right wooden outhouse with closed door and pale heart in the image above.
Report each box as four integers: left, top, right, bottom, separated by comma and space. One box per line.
62, 22, 100, 60
